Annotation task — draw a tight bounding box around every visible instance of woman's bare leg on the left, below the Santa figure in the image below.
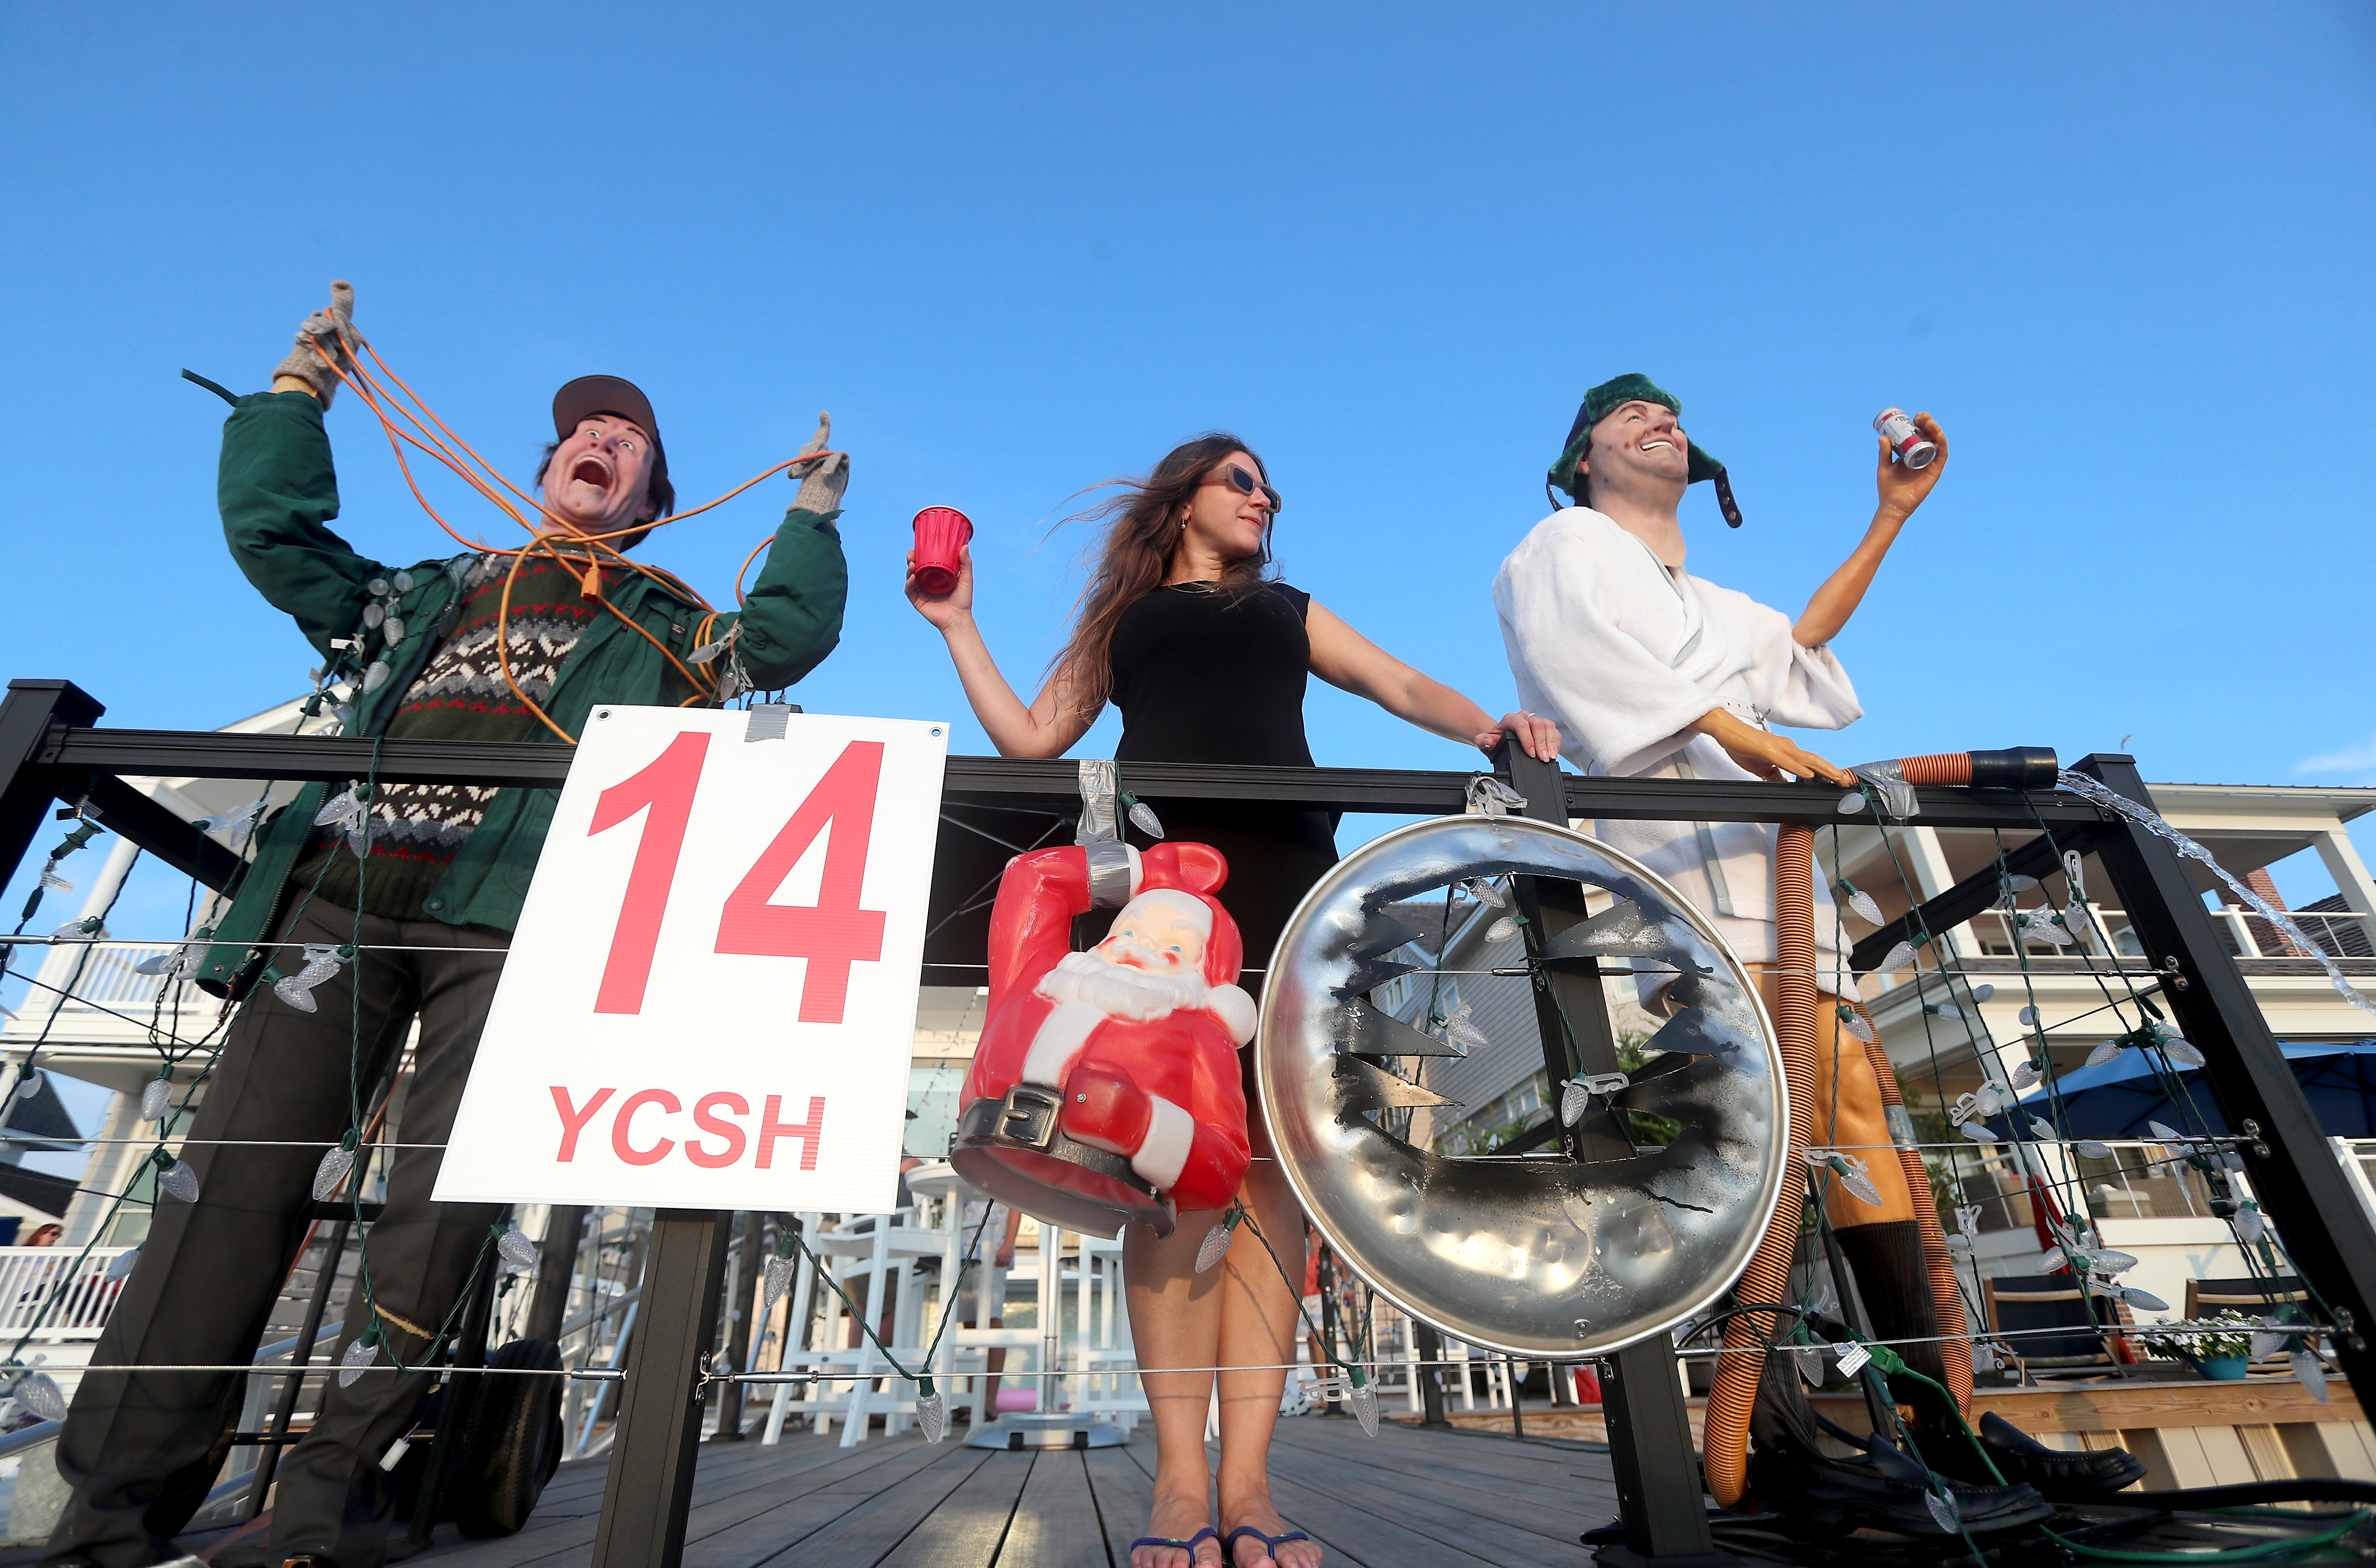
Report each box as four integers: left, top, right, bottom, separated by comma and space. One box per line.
1121, 1214, 1223, 1568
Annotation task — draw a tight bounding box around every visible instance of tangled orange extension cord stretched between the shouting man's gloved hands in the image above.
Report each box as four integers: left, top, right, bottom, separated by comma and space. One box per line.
309, 320, 846, 744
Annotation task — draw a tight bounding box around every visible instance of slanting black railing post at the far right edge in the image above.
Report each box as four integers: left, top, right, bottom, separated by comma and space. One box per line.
2077, 753, 2376, 1399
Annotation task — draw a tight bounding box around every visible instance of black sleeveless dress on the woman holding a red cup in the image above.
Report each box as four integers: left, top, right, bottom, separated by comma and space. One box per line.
1112, 582, 1338, 995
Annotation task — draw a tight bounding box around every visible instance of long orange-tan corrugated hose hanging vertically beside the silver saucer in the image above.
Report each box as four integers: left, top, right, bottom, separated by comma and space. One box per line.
1703, 824, 1818, 1509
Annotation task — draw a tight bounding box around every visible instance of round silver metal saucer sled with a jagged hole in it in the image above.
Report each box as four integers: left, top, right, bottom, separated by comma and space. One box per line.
1255, 817, 1789, 1359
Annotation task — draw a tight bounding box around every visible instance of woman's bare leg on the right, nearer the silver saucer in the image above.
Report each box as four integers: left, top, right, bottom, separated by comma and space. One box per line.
1219, 1110, 1321, 1568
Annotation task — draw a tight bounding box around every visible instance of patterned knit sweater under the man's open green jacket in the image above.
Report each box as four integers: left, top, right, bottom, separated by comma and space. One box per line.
292, 556, 627, 919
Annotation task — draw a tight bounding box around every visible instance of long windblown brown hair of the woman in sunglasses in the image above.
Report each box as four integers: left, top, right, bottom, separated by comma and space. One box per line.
1048, 430, 1271, 720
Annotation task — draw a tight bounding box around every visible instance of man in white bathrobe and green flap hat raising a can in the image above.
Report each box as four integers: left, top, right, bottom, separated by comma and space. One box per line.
1492, 375, 2143, 1518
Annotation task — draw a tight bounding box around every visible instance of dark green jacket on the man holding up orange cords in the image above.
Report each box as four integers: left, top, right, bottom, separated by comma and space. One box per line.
197, 392, 848, 993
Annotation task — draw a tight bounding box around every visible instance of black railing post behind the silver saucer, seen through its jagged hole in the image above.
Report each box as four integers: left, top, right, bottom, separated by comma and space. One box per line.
1495, 741, 1741, 1568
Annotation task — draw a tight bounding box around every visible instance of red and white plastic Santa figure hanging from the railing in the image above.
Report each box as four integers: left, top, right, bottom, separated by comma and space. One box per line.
950, 843, 1255, 1235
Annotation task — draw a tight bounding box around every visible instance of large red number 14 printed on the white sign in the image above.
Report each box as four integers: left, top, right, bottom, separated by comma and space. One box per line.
587, 732, 884, 1024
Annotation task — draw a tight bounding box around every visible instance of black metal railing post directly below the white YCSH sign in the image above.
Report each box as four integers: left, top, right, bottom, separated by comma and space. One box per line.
594, 1209, 732, 1568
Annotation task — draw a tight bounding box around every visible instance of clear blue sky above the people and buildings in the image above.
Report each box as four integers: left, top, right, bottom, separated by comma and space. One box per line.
0, 5, 2376, 1140
